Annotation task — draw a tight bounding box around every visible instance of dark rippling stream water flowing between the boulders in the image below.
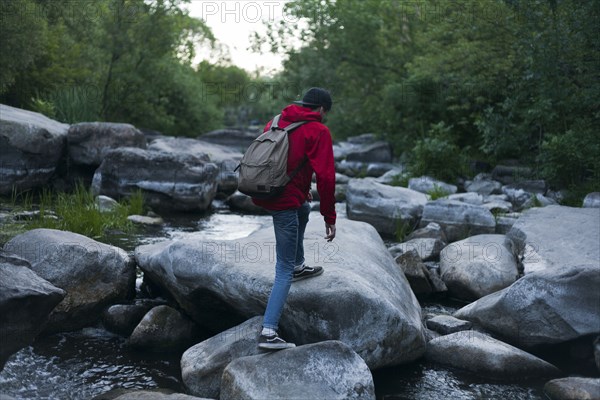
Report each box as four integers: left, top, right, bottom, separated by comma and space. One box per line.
0, 205, 546, 400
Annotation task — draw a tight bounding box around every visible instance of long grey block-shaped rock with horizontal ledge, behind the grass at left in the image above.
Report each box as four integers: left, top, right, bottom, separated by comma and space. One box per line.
92, 148, 219, 211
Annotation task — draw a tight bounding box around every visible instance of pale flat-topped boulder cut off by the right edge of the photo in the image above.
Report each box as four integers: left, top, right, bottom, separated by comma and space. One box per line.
506, 206, 600, 274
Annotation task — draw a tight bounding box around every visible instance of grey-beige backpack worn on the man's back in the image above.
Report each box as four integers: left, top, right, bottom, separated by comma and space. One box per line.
235, 115, 308, 199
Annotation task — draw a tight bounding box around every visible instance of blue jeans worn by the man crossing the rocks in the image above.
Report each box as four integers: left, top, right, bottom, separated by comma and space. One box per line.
263, 203, 310, 330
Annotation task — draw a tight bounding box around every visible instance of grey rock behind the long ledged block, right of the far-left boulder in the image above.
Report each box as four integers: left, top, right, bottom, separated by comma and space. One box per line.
67, 122, 146, 167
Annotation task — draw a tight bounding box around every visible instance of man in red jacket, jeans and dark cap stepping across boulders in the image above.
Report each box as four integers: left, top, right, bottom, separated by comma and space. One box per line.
253, 88, 336, 350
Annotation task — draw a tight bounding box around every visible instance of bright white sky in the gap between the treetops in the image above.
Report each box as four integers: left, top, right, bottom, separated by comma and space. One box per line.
185, 0, 292, 75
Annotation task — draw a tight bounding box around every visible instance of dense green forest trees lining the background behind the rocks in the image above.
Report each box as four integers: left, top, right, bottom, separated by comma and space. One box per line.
0, 0, 600, 199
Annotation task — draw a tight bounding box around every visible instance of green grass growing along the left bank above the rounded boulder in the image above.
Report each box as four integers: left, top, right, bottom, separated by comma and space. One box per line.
1, 183, 144, 241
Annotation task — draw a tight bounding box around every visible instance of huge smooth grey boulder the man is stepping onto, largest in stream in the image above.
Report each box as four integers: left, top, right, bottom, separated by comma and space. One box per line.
135, 214, 425, 368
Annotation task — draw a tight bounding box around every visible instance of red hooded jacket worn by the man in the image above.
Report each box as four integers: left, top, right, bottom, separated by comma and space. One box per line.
252, 104, 336, 225
